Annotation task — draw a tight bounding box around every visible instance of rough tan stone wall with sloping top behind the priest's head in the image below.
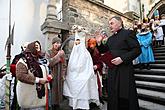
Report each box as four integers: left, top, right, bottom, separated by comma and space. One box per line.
63, 0, 133, 35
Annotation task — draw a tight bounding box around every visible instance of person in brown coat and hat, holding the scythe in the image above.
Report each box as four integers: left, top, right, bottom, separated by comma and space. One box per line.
46, 37, 67, 110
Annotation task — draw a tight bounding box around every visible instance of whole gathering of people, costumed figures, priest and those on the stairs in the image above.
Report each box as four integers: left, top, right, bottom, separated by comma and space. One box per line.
0, 14, 165, 110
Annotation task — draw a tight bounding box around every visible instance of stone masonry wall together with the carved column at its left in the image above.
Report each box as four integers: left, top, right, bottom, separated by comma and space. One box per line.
41, 0, 137, 58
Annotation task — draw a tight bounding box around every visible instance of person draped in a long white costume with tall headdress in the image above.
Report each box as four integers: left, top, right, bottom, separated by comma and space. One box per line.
63, 25, 99, 110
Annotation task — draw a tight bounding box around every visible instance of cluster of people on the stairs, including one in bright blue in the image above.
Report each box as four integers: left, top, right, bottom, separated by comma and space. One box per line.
133, 14, 165, 69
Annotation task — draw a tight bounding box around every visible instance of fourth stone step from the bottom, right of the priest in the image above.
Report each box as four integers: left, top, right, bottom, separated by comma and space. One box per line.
135, 74, 165, 83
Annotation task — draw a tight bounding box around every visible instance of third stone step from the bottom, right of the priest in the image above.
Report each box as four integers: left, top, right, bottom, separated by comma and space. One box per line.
136, 81, 165, 92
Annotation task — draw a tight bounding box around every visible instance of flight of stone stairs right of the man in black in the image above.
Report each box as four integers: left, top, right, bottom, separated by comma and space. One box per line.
135, 45, 165, 110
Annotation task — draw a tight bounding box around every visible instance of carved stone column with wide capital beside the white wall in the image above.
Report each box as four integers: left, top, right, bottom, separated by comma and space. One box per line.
41, 0, 68, 50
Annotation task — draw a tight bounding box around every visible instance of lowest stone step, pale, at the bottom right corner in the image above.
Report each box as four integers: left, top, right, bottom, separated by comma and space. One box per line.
138, 99, 165, 110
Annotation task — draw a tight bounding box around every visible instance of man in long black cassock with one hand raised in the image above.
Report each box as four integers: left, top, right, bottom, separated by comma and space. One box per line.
96, 16, 141, 110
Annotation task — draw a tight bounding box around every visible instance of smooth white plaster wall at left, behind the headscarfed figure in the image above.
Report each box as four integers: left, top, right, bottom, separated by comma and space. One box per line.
0, 0, 47, 67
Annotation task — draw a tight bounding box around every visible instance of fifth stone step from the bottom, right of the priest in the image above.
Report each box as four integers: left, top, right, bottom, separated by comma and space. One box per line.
134, 68, 165, 76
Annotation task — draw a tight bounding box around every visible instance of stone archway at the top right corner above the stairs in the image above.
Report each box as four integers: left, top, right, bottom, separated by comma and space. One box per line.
148, 0, 165, 18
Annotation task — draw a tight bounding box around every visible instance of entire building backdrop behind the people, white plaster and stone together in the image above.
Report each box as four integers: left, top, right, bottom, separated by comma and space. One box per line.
0, 0, 165, 66
